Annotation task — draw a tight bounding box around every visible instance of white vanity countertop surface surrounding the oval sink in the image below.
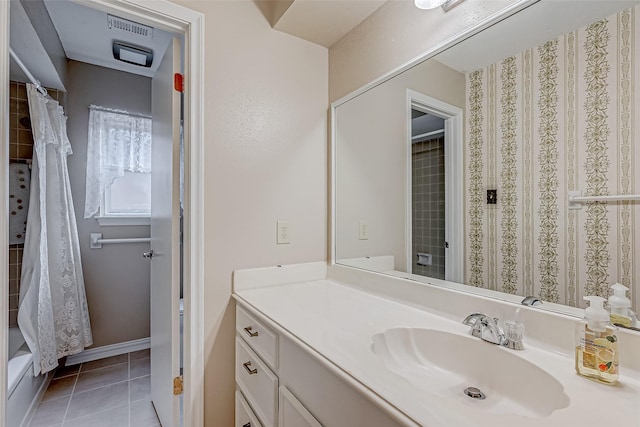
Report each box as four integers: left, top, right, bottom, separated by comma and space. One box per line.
234, 280, 640, 427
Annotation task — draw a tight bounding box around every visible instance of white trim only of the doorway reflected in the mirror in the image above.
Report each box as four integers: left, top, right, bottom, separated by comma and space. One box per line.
405, 89, 464, 283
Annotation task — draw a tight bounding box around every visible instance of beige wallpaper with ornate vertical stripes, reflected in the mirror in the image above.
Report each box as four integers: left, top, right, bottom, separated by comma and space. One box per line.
465, 8, 640, 309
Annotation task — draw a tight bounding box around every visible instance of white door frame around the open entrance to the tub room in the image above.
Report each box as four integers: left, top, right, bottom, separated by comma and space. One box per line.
0, 0, 203, 425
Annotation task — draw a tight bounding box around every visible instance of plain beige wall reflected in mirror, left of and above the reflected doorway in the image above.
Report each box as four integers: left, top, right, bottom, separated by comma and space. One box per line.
336, 59, 465, 271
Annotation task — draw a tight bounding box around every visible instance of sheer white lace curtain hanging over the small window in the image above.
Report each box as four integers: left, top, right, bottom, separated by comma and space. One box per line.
84, 105, 151, 218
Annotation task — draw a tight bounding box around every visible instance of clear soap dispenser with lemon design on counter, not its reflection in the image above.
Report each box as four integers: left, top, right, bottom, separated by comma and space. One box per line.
576, 296, 618, 384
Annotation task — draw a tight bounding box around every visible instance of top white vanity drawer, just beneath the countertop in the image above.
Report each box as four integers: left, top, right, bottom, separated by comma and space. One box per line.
236, 306, 278, 369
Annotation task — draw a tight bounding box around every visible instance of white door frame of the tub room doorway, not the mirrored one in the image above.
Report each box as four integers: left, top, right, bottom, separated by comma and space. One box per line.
0, 0, 204, 426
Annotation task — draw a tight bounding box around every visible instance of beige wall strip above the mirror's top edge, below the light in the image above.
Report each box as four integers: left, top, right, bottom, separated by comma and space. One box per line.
329, 0, 518, 101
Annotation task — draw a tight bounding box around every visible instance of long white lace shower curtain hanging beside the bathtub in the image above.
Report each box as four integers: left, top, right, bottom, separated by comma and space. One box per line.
18, 84, 93, 375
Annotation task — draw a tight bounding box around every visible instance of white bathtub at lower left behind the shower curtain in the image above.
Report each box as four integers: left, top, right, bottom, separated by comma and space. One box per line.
7, 327, 49, 427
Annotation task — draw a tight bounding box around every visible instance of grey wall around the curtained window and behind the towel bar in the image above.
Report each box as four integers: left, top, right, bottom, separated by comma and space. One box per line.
66, 61, 151, 347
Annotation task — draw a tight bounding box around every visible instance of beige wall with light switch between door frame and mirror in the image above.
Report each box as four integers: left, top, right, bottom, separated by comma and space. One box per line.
170, 0, 328, 427
